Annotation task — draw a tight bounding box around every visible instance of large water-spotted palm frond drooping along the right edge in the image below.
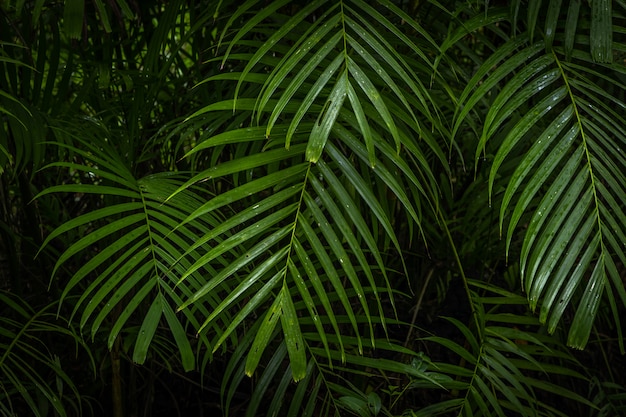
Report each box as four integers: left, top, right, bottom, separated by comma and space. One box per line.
457, 6, 626, 349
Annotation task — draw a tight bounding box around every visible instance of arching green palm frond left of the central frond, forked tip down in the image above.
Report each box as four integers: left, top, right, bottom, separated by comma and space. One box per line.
38, 138, 212, 370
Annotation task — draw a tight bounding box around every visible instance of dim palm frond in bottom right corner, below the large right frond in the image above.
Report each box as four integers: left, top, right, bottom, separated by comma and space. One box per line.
411, 281, 595, 416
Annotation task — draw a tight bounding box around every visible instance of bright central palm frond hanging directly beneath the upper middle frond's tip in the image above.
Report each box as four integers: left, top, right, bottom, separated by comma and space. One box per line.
173, 122, 402, 379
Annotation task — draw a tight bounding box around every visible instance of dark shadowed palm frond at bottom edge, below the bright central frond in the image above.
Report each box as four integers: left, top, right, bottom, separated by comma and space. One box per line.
222, 312, 445, 416
